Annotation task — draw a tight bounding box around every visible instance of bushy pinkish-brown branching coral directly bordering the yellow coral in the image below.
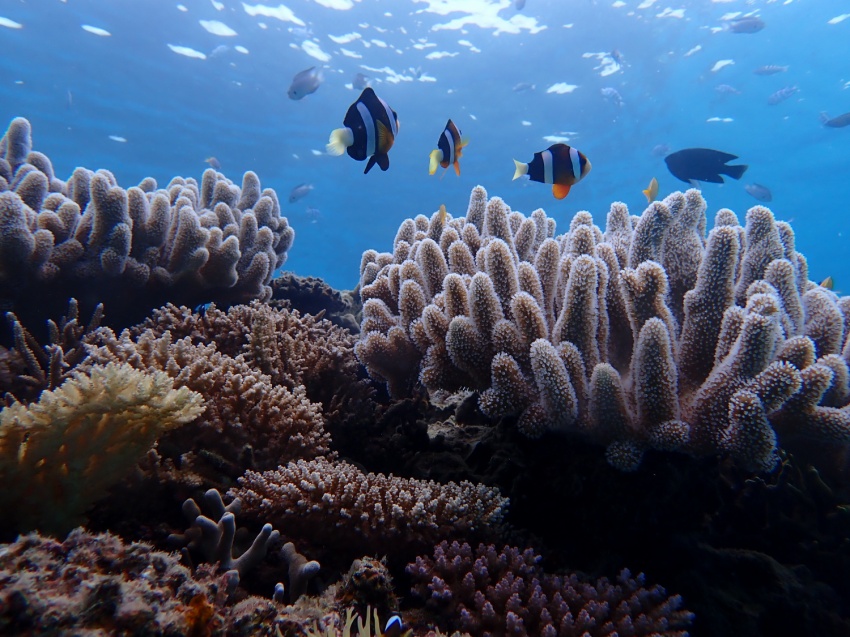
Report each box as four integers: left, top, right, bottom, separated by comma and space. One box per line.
80, 328, 330, 483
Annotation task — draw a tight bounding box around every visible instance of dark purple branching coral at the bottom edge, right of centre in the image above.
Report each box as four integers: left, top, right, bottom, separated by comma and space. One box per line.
407, 541, 693, 637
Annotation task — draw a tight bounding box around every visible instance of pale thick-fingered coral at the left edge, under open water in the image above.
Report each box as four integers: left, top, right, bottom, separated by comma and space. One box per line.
0, 118, 294, 340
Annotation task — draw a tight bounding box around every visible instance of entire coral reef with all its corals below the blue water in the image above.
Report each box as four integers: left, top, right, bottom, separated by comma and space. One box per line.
0, 118, 850, 637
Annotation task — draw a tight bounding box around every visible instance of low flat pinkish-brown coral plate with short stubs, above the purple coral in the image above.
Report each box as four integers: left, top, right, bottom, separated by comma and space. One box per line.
230, 458, 507, 555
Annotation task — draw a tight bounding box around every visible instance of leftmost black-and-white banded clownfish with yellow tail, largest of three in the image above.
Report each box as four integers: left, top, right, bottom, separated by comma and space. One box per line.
327, 86, 398, 175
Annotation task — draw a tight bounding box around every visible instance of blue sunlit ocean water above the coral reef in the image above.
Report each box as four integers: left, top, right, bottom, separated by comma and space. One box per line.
0, 0, 850, 290
